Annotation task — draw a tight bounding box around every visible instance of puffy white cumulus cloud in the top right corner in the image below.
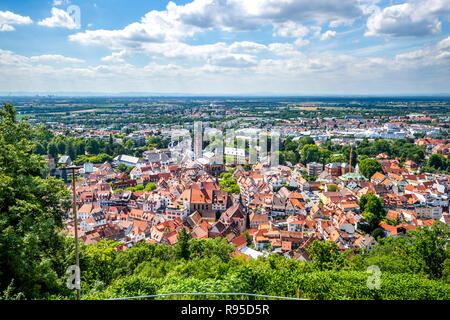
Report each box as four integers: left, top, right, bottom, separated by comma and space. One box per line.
365, 0, 450, 37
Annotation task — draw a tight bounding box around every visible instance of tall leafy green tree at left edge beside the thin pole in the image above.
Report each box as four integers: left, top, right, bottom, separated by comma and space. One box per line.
0, 104, 70, 298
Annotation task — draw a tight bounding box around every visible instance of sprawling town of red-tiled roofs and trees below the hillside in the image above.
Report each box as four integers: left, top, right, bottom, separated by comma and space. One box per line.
18, 96, 450, 261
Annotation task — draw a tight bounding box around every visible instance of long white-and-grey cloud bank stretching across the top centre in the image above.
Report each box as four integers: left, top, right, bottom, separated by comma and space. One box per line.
69, 0, 362, 50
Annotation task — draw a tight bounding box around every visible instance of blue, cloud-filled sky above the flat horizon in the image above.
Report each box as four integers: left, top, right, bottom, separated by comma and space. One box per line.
0, 0, 450, 95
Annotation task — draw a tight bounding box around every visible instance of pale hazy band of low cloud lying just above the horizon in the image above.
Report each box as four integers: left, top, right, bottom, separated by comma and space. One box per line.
0, 37, 450, 94
